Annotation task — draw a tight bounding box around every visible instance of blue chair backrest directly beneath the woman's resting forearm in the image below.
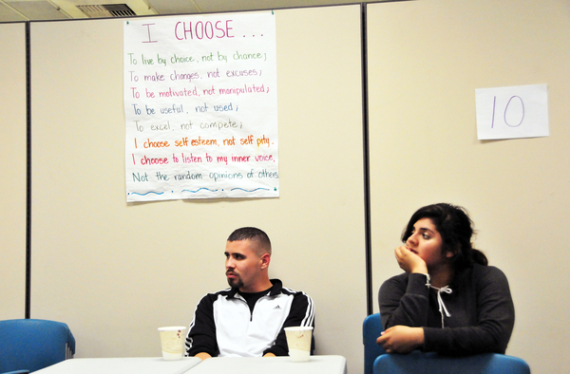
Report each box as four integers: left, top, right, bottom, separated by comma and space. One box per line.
374, 351, 530, 374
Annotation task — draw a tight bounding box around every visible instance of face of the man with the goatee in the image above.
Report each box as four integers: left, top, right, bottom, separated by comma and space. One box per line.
224, 240, 263, 292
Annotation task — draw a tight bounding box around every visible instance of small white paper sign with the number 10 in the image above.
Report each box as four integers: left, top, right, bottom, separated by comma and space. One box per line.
475, 84, 549, 140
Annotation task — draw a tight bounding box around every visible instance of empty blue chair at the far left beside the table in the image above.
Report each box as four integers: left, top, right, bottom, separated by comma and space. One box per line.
0, 319, 75, 373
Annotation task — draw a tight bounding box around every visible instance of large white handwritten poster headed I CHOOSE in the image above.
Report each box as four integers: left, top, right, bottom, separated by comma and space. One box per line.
124, 11, 279, 202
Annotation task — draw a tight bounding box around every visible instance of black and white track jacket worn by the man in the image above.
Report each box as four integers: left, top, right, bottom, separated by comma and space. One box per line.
186, 279, 315, 357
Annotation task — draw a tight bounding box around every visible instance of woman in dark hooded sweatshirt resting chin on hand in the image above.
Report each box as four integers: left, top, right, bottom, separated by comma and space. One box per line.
377, 203, 515, 355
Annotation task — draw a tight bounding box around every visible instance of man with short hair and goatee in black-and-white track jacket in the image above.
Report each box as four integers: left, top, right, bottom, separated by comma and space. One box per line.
186, 227, 315, 360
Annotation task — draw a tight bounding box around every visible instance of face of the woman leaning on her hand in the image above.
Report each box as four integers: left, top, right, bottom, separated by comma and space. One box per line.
406, 218, 453, 269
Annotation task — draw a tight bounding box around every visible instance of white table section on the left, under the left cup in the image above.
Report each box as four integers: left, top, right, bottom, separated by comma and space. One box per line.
34, 357, 202, 374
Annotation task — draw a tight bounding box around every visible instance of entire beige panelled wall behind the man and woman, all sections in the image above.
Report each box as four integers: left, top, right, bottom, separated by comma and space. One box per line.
0, 0, 570, 373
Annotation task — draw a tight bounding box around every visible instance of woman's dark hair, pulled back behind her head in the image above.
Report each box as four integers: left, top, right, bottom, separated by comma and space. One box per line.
402, 203, 489, 271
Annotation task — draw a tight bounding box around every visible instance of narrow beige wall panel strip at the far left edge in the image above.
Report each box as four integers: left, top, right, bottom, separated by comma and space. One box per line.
0, 23, 26, 320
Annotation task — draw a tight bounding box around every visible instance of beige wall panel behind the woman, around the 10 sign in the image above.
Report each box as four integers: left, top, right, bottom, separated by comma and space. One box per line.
368, 0, 570, 373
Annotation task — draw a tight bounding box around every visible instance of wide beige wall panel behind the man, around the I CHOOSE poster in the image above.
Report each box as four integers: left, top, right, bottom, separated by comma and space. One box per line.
26, 6, 366, 373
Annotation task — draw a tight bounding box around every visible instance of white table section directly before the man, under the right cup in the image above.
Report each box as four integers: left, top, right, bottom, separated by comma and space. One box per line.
187, 356, 346, 374
